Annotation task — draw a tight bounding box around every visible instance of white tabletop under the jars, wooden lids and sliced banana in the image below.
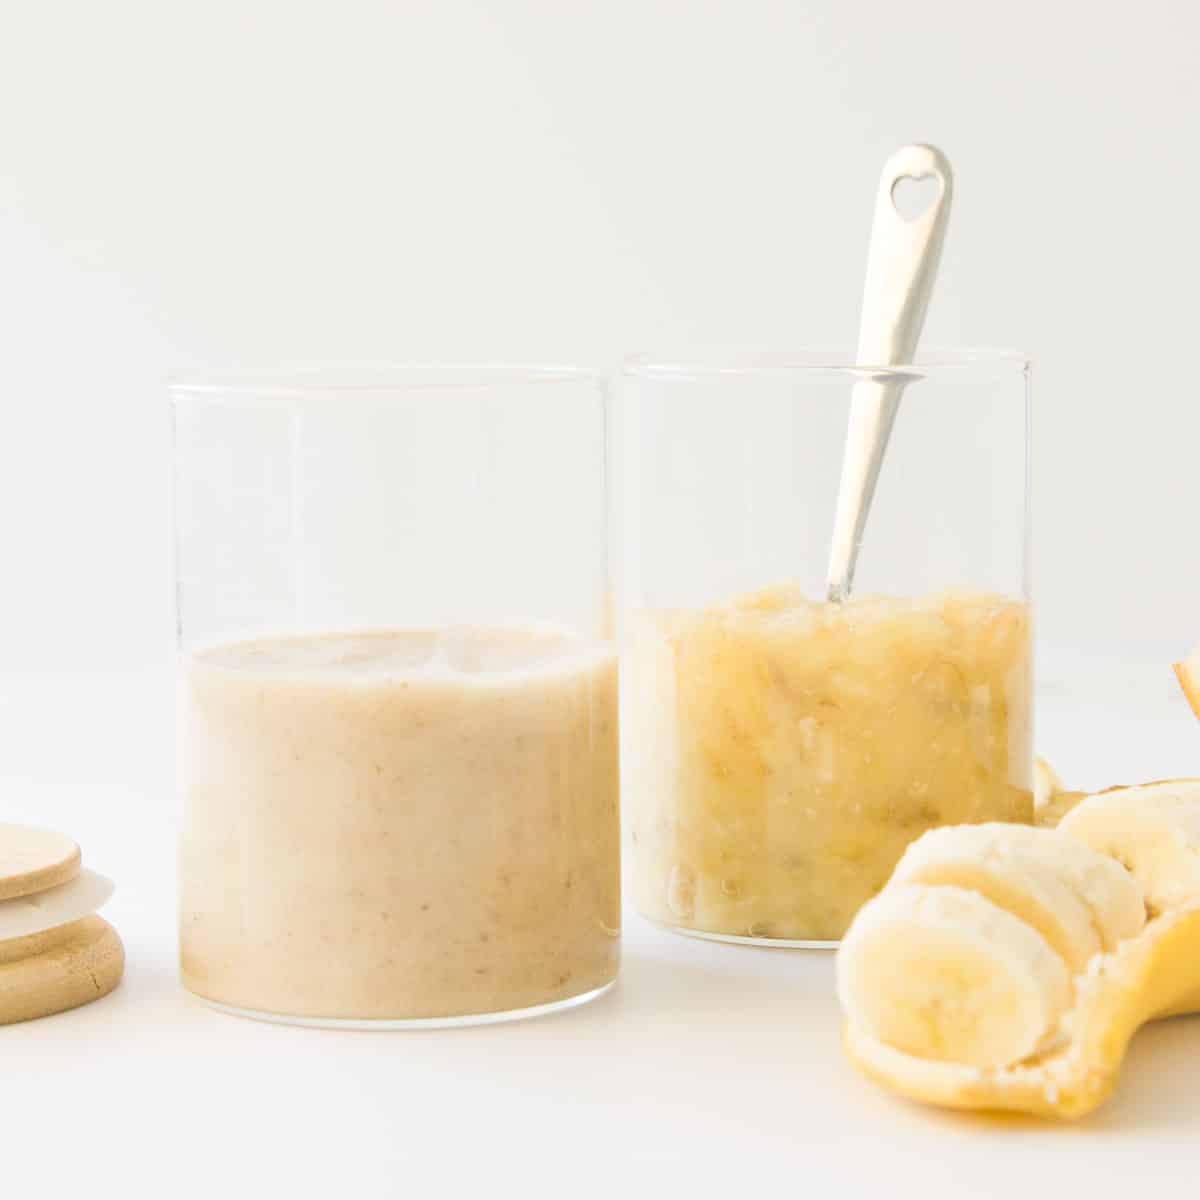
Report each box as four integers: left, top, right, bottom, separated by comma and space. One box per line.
0, 655, 1200, 1200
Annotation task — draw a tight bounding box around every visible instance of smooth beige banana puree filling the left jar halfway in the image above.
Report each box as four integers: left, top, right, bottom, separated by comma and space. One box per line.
180, 630, 620, 1020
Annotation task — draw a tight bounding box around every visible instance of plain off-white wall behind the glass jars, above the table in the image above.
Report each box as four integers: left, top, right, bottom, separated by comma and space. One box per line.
0, 0, 1200, 666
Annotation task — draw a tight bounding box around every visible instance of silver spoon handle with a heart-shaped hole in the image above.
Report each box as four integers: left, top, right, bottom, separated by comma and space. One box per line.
828, 145, 954, 601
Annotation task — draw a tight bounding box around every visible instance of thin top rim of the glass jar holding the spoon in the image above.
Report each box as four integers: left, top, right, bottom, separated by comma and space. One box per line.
619, 347, 1033, 379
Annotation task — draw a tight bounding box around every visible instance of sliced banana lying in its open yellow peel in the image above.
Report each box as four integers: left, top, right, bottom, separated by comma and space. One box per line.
838, 780, 1200, 1117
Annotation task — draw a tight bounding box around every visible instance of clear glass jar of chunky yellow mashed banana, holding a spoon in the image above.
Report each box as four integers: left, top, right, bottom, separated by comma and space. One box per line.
620, 352, 1033, 946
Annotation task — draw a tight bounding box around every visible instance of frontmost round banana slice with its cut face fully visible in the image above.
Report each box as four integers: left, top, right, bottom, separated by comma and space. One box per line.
838, 884, 1072, 1068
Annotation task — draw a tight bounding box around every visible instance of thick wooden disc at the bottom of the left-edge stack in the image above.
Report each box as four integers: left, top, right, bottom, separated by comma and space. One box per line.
0, 917, 125, 1025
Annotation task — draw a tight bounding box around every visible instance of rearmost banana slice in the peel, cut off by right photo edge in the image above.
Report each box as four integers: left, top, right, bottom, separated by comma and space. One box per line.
1058, 780, 1200, 916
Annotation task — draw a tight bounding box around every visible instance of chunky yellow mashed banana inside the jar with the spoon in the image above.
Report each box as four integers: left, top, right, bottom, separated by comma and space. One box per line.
625, 588, 1033, 941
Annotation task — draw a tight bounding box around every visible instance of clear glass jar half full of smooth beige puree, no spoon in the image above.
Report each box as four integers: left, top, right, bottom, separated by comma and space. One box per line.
172, 367, 620, 1026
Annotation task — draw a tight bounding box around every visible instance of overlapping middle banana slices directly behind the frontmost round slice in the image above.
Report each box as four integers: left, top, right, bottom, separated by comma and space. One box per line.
892, 822, 1145, 973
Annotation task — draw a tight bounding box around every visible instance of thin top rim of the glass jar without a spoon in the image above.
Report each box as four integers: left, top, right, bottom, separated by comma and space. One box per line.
167, 362, 610, 400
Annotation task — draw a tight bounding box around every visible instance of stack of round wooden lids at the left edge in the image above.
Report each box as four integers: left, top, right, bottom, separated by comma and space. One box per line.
0, 824, 125, 1025
